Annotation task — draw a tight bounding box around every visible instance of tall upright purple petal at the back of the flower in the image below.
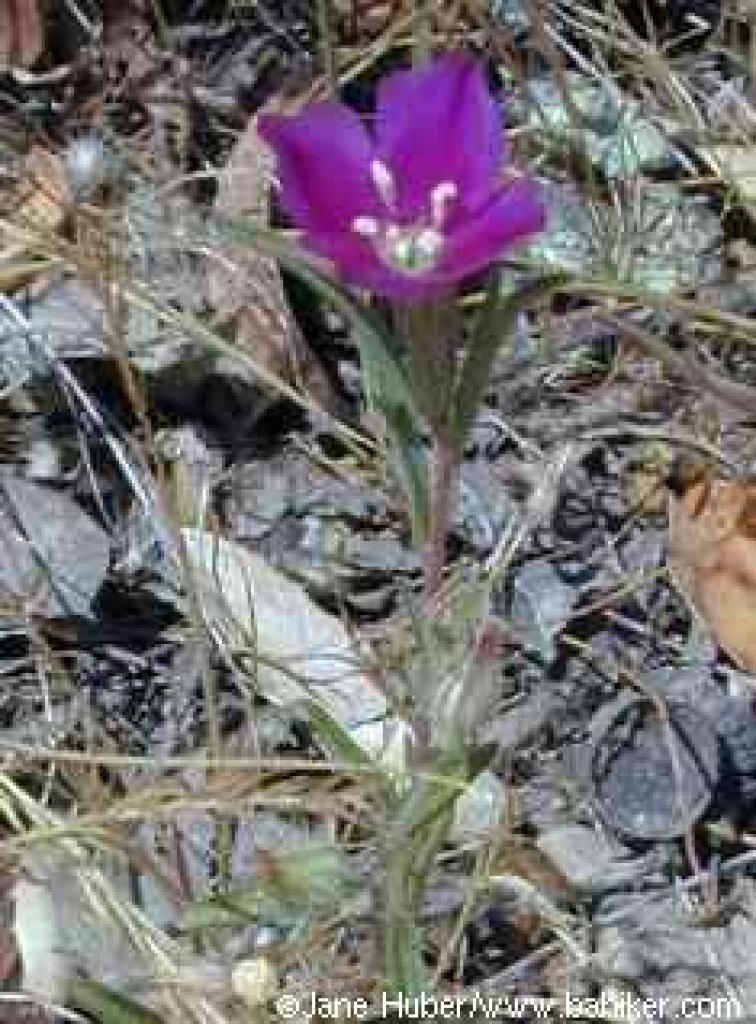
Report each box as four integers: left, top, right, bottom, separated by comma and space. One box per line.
375, 53, 504, 220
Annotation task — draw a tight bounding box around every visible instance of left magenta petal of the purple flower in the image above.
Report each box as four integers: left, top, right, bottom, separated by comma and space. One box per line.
257, 103, 378, 232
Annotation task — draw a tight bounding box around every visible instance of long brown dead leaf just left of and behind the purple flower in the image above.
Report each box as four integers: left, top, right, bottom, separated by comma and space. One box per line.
208, 108, 338, 412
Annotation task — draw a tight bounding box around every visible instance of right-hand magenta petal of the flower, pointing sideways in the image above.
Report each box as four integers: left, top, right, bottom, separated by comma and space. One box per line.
436, 178, 546, 280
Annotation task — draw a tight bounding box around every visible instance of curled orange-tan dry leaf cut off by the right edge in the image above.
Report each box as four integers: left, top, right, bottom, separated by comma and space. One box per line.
669, 469, 756, 672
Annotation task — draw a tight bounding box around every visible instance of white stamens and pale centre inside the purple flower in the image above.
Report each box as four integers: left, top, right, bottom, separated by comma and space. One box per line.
351, 160, 457, 275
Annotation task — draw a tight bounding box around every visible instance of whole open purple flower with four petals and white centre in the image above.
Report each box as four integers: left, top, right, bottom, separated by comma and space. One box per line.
258, 53, 545, 302
